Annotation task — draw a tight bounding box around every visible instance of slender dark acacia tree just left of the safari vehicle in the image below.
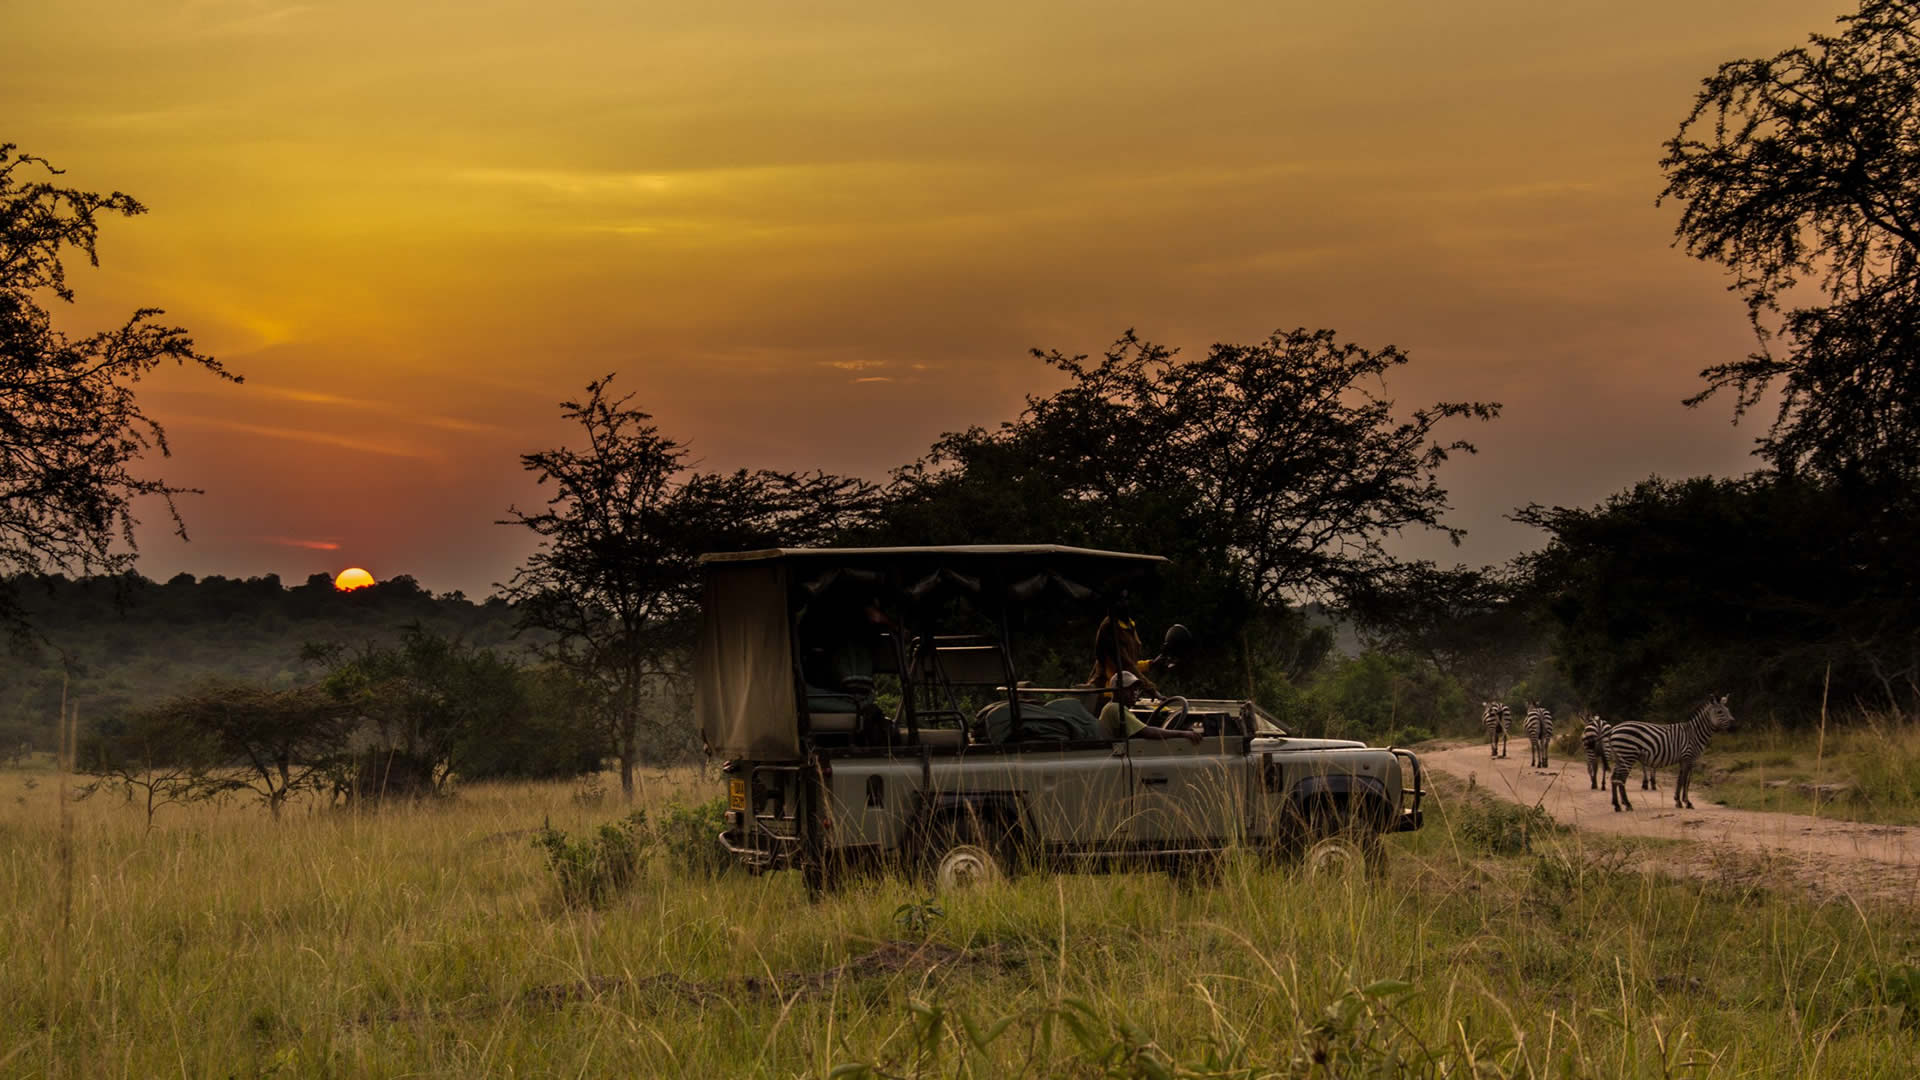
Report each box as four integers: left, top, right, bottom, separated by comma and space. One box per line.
499, 375, 872, 798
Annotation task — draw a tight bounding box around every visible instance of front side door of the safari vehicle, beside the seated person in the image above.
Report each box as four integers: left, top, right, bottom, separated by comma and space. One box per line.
1127, 736, 1248, 847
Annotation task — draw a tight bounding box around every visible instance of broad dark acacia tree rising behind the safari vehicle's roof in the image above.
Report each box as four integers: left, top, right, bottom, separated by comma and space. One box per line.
877, 329, 1500, 688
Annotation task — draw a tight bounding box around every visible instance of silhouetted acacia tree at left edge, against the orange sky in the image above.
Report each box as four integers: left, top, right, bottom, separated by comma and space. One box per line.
0, 142, 240, 623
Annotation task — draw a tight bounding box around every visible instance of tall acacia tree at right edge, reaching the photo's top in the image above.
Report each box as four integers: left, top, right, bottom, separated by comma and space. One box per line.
1661, 0, 1920, 480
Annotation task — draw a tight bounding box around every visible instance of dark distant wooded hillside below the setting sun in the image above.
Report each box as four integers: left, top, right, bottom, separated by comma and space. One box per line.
0, 575, 538, 749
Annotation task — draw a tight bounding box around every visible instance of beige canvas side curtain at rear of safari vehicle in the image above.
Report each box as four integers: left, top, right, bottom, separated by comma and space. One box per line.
693, 563, 801, 761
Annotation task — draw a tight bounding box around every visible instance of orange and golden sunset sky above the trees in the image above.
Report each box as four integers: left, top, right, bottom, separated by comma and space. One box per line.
0, 0, 1851, 596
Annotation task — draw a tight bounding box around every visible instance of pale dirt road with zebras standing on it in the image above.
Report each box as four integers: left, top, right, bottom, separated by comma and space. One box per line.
1421, 740, 1920, 907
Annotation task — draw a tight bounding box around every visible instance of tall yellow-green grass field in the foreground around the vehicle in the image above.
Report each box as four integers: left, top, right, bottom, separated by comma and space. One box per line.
0, 771, 1920, 1078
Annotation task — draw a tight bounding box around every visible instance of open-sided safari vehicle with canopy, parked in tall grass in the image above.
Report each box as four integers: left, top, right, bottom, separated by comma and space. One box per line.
695, 546, 1423, 890
